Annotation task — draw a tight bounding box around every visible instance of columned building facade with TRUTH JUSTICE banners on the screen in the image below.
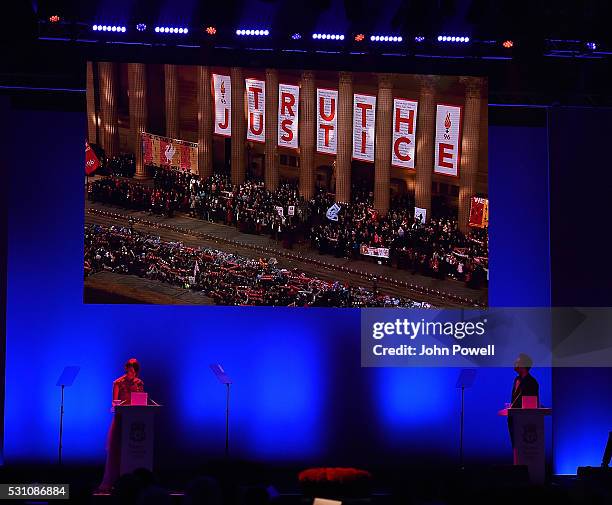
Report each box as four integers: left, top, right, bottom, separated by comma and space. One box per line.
87, 62, 488, 231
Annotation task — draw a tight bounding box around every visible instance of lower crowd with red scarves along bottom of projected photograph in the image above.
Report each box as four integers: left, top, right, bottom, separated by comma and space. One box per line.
84, 225, 429, 307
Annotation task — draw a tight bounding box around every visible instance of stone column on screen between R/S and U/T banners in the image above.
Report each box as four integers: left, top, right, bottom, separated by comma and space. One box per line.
299, 70, 316, 200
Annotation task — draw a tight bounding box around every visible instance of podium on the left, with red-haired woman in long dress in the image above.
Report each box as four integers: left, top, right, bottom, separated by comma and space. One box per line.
115, 405, 159, 475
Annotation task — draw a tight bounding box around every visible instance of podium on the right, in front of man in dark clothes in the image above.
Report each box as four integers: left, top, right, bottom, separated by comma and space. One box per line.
499, 408, 552, 484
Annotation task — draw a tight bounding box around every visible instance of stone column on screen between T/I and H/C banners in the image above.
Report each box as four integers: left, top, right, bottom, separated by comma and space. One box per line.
374, 74, 393, 216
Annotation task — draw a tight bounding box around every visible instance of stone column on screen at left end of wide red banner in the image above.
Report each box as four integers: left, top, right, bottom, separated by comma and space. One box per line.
128, 63, 147, 178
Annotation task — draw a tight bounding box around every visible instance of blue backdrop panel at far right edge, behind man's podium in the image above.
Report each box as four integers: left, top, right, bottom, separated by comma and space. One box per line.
549, 107, 612, 473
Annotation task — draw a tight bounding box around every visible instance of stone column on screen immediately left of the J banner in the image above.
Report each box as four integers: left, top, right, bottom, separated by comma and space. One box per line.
197, 66, 213, 179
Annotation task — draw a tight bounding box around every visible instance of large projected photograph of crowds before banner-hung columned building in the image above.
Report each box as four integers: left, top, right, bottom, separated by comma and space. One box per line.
84, 61, 489, 308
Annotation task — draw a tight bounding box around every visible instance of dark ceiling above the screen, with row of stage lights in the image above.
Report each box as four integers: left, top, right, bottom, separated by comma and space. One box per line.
0, 0, 612, 106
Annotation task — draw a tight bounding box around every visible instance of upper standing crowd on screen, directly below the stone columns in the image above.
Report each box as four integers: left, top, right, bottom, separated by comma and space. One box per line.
89, 169, 488, 288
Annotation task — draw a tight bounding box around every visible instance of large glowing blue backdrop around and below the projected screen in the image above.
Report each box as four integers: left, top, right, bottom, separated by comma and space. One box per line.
5, 104, 551, 464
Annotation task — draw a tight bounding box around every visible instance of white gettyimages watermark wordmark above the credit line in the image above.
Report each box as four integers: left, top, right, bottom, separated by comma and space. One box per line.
372, 318, 487, 340
